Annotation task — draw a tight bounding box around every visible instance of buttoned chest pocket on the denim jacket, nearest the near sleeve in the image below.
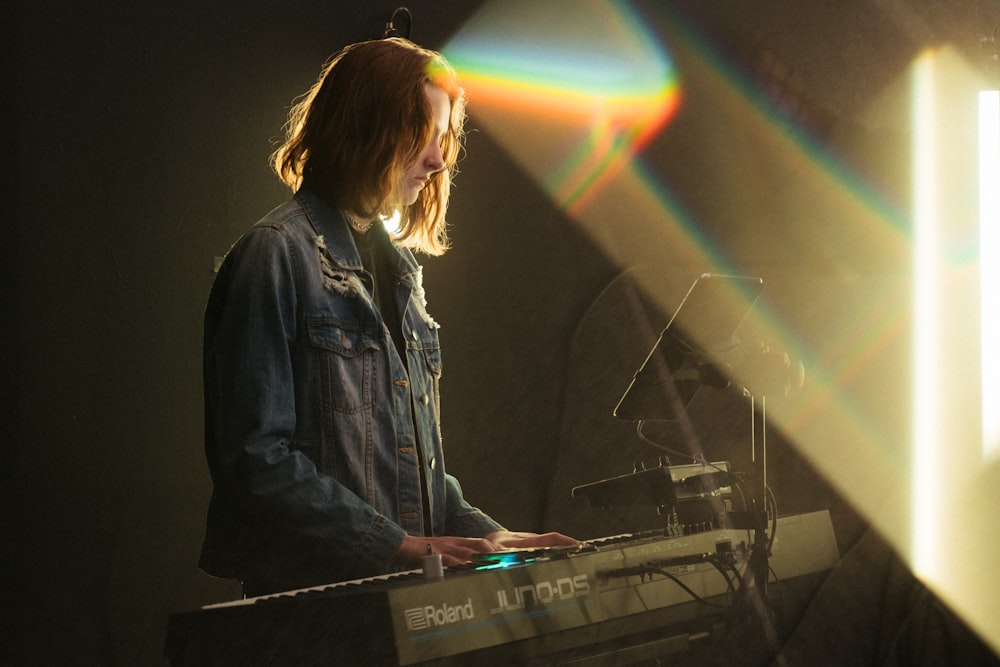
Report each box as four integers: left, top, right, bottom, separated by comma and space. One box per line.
306, 315, 380, 414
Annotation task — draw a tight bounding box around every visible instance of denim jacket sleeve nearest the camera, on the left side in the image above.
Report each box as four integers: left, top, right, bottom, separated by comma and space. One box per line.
204, 226, 404, 580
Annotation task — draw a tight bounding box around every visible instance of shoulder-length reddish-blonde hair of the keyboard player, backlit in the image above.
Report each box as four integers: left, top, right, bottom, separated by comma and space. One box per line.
271, 37, 465, 255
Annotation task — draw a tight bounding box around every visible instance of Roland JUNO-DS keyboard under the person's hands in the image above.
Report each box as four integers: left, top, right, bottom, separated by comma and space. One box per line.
165, 511, 838, 667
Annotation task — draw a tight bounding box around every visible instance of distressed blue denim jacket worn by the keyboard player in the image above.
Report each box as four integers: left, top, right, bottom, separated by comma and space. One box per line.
200, 190, 500, 588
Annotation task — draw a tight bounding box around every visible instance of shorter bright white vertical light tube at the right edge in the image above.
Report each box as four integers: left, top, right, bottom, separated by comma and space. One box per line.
979, 90, 1000, 458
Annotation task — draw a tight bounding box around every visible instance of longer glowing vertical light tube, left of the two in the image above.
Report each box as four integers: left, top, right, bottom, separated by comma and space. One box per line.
911, 53, 941, 576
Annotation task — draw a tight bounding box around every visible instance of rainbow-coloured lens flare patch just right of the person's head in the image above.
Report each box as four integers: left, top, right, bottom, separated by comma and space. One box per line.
444, 2, 680, 215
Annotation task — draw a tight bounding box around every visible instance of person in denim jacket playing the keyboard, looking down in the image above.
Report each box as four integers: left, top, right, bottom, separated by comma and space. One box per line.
200, 38, 574, 595
